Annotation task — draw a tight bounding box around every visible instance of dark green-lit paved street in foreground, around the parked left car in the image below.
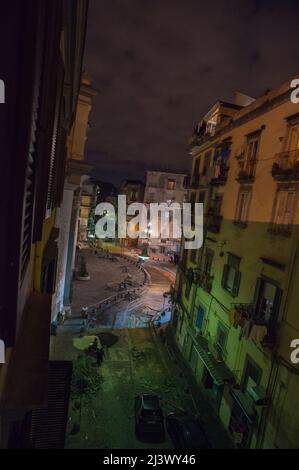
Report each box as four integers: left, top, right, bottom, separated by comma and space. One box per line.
60, 328, 192, 449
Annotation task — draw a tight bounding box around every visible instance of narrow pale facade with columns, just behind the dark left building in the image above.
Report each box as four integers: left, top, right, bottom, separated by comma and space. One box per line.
52, 71, 97, 321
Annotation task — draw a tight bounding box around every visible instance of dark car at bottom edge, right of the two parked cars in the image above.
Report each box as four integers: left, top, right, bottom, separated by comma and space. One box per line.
166, 413, 211, 449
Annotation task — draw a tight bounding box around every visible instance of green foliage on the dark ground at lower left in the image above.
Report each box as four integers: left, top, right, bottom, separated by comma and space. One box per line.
71, 354, 103, 400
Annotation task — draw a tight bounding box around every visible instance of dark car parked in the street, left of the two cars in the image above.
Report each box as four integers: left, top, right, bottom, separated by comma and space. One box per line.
135, 394, 165, 440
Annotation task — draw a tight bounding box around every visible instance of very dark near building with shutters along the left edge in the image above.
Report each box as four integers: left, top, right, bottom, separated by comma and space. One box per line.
0, 0, 88, 448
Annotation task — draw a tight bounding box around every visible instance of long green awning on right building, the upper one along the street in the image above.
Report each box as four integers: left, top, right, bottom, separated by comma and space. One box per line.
195, 336, 234, 385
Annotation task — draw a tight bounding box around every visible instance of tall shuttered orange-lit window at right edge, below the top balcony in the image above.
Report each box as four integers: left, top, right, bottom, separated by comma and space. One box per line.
273, 187, 297, 228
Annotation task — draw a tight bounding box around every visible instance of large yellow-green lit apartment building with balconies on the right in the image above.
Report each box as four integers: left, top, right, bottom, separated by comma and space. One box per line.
173, 76, 299, 448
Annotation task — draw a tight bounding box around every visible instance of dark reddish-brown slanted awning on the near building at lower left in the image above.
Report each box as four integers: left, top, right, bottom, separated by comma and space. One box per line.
0, 292, 52, 410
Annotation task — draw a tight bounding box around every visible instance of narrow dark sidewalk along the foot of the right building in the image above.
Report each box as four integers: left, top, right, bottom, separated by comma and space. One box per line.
153, 324, 234, 449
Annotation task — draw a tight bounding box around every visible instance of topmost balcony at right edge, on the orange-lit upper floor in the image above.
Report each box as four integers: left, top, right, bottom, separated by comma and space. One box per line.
272, 149, 299, 181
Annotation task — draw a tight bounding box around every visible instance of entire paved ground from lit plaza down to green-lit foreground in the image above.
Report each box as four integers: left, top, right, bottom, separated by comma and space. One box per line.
51, 255, 230, 449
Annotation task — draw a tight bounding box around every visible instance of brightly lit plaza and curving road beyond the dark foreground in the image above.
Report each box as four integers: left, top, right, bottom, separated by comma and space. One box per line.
58, 252, 175, 334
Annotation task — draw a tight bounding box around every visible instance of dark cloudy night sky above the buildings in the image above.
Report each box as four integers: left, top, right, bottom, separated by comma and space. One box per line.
84, 0, 299, 184
